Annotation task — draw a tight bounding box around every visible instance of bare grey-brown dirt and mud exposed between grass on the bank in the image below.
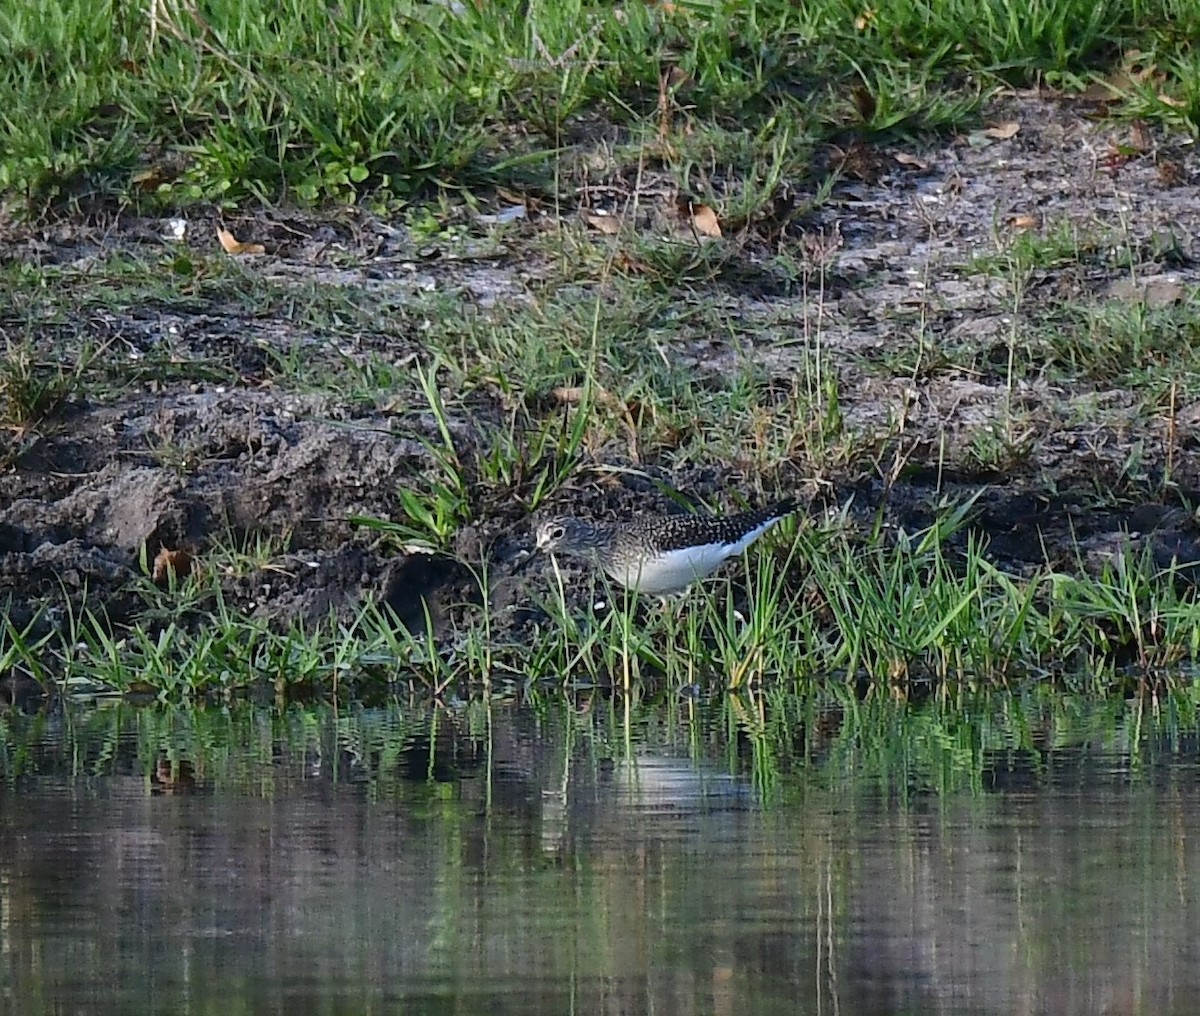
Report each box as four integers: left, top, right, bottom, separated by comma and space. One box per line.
0, 96, 1200, 627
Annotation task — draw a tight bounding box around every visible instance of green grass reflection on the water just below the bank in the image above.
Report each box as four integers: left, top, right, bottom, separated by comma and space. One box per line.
0, 684, 1200, 805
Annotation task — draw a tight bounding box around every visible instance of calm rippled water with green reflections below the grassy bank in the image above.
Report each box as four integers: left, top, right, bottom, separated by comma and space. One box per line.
0, 701, 1200, 1016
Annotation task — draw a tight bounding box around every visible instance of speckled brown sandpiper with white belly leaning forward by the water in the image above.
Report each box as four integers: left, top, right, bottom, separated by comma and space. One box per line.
538, 498, 796, 596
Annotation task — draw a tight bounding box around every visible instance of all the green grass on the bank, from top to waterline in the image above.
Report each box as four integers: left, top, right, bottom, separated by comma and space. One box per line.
7, 0, 1200, 701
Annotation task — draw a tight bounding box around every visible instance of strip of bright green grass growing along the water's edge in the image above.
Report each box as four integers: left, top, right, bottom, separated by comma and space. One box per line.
0, 494, 1200, 702
